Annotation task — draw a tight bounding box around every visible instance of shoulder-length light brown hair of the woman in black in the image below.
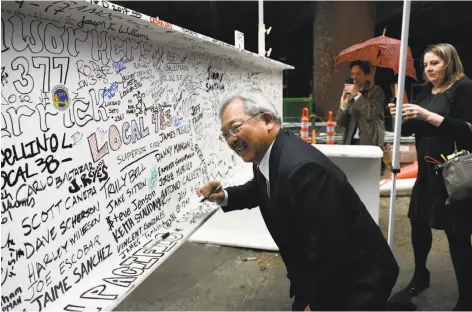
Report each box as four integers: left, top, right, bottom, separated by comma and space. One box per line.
423, 43, 464, 86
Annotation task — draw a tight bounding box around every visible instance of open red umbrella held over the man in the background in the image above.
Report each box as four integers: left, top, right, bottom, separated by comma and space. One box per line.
334, 35, 418, 80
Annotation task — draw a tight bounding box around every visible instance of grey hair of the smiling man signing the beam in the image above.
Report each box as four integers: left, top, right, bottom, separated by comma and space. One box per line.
220, 91, 282, 125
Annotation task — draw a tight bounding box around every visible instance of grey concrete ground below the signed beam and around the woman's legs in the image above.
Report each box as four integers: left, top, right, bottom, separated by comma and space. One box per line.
116, 197, 457, 311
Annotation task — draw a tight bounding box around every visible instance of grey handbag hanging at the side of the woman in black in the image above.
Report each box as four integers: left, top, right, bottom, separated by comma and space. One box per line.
438, 123, 472, 205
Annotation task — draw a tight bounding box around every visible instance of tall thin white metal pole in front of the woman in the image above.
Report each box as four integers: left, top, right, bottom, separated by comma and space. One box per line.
388, 0, 411, 250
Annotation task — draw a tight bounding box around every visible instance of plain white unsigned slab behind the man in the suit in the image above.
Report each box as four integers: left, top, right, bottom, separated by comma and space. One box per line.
189, 144, 383, 251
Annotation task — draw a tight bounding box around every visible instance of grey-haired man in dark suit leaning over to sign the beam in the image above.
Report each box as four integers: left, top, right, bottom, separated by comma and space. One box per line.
197, 92, 399, 311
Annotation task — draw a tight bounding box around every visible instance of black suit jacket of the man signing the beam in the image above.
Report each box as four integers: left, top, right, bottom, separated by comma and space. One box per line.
222, 129, 399, 310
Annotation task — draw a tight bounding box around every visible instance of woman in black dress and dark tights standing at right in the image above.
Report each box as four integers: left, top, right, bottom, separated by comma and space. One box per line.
389, 43, 472, 311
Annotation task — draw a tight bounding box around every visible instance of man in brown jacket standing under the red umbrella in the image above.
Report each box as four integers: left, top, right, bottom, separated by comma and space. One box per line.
336, 60, 385, 148
